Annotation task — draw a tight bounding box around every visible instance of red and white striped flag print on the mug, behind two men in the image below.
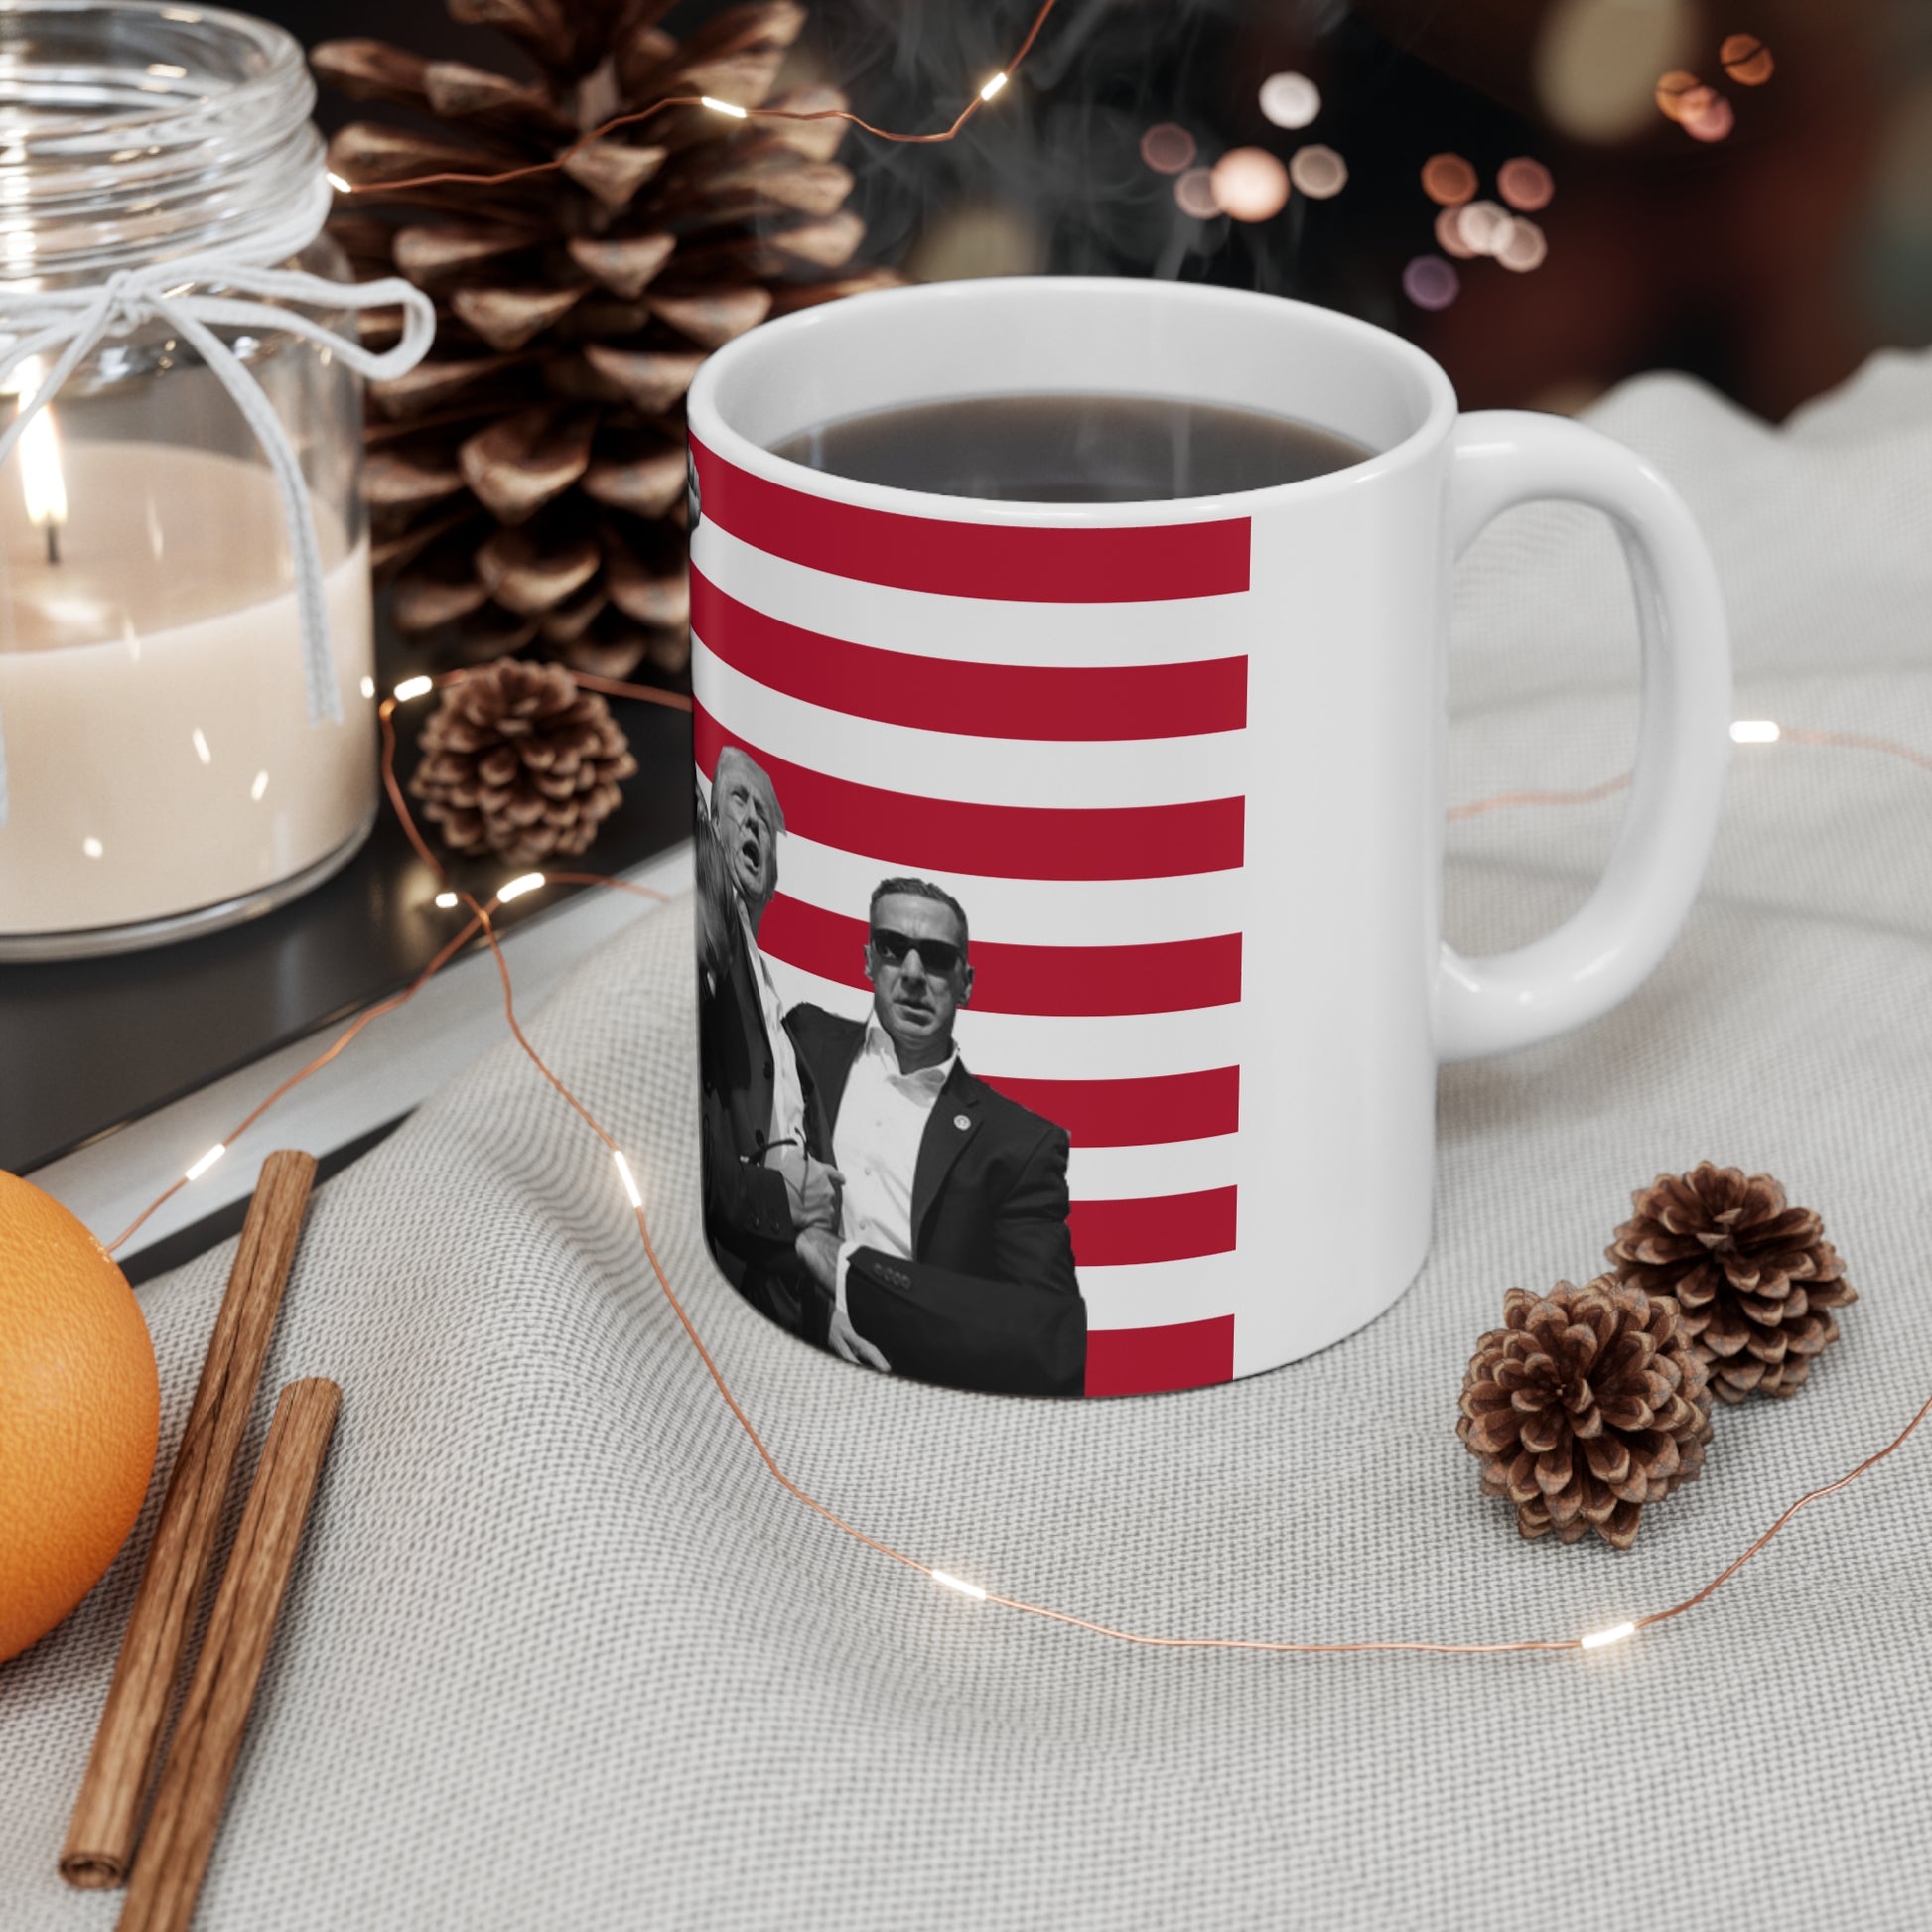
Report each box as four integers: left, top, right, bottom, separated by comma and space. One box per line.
692, 439, 1248, 1395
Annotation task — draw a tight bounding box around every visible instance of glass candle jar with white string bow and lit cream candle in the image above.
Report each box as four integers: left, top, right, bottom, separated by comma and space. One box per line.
0, 0, 376, 958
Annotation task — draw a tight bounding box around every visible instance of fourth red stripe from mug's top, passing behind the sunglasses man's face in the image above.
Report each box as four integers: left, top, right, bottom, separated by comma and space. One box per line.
758, 893, 1240, 1017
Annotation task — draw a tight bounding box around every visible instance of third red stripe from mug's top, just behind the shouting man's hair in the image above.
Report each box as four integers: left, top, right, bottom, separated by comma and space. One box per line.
692, 705, 1242, 879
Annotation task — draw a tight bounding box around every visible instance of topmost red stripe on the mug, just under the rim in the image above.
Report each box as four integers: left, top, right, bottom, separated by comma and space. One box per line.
692, 437, 1248, 603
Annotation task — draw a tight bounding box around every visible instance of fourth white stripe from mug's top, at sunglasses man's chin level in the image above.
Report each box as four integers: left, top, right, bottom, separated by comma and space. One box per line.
765, 952, 1242, 1080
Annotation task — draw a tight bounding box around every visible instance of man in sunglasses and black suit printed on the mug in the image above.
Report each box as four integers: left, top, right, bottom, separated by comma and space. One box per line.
786, 879, 1086, 1395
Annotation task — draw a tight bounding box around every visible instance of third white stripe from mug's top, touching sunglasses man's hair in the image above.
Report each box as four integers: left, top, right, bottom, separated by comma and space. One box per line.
778, 827, 1244, 947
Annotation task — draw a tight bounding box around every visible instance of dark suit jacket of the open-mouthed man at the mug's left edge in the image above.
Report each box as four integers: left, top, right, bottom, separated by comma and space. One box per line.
698, 912, 831, 1341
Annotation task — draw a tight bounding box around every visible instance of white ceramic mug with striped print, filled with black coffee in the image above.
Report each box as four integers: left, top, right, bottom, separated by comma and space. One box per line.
690, 278, 1731, 1395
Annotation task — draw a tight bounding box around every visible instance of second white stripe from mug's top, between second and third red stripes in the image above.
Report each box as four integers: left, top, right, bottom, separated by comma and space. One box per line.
692, 633, 1248, 807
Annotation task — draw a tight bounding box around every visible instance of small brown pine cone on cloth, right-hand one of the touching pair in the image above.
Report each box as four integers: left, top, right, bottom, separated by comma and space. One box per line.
1605, 1162, 1859, 1403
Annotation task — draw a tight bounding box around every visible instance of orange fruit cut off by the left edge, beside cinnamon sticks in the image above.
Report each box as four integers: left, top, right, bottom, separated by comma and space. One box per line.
0, 1173, 161, 1660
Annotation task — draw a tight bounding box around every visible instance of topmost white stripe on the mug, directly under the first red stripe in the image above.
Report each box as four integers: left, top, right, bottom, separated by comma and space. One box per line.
692, 521, 1252, 664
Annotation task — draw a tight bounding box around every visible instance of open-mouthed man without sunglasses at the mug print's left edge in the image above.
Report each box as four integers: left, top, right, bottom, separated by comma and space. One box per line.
696, 746, 839, 1342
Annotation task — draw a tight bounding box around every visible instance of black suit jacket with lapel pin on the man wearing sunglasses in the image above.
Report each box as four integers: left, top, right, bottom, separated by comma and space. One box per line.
784, 1007, 1086, 1395
